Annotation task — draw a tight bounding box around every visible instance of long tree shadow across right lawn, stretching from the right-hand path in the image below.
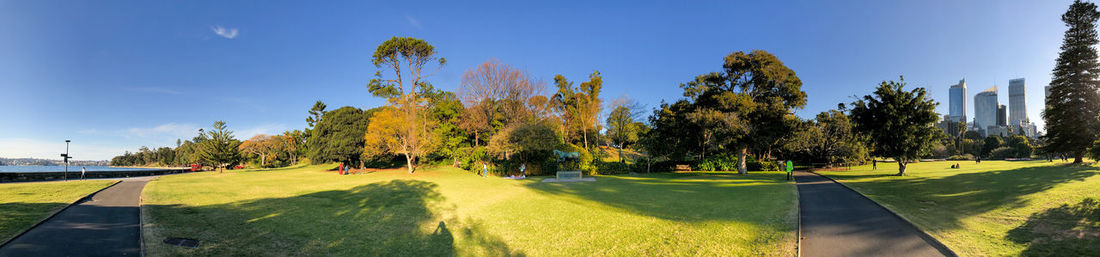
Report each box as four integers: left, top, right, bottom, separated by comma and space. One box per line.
844, 166, 1100, 228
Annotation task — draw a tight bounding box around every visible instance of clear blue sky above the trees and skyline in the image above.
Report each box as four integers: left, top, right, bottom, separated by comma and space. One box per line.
0, 0, 1071, 159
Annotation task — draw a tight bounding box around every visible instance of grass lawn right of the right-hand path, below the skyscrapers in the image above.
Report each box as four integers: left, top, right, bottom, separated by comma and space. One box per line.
820, 160, 1100, 256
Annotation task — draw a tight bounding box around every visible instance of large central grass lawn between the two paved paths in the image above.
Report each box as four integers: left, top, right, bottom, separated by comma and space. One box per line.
143, 166, 798, 256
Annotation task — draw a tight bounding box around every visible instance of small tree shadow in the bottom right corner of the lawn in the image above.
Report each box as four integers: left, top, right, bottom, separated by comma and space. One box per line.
1005, 198, 1100, 256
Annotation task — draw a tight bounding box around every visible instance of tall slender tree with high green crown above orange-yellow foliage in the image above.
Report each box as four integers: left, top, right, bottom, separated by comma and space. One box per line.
360, 36, 447, 174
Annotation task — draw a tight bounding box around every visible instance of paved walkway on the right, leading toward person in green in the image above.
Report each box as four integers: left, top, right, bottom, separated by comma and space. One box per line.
794, 171, 950, 257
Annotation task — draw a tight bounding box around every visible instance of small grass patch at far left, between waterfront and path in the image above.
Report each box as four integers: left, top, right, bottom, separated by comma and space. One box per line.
0, 180, 114, 242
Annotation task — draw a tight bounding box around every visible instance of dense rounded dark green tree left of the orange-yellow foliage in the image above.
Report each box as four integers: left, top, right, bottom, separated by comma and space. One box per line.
309, 107, 371, 165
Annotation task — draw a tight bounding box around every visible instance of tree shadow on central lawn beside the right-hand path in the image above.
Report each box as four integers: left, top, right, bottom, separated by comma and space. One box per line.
527, 172, 794, 224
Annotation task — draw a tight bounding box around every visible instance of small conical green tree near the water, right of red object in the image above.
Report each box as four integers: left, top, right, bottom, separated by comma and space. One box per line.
199, 121, 241, 169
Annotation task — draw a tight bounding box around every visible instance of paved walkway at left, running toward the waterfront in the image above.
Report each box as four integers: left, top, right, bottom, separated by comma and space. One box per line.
0, 177, 155, 257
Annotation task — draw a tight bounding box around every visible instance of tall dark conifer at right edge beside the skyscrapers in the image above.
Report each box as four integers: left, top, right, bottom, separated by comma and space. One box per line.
1043, 0, 1100, 164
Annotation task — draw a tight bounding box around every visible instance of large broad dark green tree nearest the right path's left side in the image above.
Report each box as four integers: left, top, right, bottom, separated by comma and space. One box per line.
681, 49, 806, 174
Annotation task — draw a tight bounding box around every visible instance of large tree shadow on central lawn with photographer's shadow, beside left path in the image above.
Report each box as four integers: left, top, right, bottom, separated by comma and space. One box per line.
146, 180, 523, 256
